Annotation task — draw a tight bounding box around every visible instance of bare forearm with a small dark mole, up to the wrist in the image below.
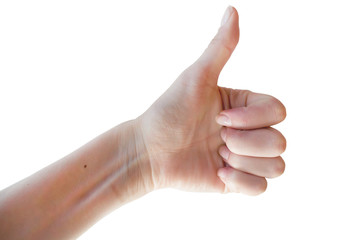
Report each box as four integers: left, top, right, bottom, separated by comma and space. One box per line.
0, 120, 153, 239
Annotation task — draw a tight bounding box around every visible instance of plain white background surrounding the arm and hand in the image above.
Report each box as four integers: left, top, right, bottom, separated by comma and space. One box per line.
0, 0, 360, 239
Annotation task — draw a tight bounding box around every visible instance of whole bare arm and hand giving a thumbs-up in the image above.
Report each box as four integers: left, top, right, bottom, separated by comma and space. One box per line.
0, 7, 286, 239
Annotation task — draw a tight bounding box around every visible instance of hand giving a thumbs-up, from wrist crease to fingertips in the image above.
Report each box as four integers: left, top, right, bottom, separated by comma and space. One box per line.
138, 7, 286, 195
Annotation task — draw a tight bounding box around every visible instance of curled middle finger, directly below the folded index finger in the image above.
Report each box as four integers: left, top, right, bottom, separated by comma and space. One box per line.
221, 127, 286, 157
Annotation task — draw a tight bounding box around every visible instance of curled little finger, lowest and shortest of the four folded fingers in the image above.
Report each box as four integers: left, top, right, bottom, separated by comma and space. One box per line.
217, 167, 267, 195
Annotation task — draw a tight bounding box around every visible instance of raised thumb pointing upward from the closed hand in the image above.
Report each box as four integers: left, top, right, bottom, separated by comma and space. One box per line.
195, 6, 239, 80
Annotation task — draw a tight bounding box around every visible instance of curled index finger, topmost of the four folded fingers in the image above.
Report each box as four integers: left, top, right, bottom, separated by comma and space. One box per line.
216, 88, 286, 129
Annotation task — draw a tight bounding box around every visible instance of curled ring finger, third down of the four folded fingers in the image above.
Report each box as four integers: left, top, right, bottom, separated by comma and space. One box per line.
219, 145, 285, 178
